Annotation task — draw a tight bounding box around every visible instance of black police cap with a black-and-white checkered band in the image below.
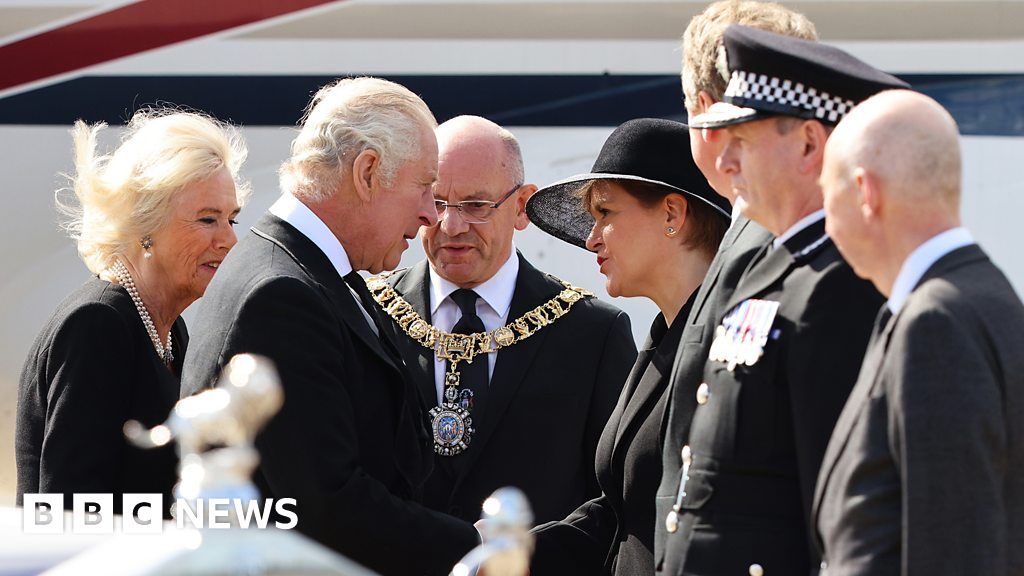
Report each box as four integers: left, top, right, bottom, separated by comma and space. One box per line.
690, 24, 910, 128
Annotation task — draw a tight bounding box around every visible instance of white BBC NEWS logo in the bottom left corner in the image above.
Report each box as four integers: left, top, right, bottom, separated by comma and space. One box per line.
22, 494, 299, 534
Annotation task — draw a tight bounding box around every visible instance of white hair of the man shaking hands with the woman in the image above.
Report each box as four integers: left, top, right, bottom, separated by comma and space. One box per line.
279, 77, 437, 202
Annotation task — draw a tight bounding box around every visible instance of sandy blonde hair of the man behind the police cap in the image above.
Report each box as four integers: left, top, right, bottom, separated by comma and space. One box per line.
682, 0, 818, 113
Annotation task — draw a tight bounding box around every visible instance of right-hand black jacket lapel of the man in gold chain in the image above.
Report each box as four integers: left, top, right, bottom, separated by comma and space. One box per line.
452, 254, 557, 485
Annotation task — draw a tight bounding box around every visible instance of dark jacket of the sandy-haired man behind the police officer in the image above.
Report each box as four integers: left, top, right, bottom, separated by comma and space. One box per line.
654, 216, 772, 570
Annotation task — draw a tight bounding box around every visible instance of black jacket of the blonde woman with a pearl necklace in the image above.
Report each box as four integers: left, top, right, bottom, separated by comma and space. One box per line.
14, 278, 188, 516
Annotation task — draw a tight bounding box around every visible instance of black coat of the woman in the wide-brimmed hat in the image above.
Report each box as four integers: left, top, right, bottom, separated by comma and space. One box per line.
530, 292, 696, 576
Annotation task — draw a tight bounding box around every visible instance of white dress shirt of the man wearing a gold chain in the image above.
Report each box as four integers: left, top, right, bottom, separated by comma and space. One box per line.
430, 245, 519, 404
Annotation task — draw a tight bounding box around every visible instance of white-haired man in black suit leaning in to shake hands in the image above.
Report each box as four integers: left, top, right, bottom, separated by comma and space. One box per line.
181, 78, 478, 575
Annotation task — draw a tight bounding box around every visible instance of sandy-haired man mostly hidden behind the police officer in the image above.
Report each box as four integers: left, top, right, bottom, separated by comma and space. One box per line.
654, 0, 817, 574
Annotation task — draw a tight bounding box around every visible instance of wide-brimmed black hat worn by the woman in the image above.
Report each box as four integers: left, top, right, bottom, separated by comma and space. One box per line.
526, 118, 731, 249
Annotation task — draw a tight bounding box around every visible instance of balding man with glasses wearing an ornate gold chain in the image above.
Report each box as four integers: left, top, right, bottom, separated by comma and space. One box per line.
385, 116, 636, 522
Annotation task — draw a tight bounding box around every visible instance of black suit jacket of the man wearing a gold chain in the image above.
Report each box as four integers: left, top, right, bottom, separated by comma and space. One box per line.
391, 254, 636, 522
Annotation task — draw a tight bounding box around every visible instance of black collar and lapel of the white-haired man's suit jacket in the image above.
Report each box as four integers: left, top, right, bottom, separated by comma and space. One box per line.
252, 214, 401, 372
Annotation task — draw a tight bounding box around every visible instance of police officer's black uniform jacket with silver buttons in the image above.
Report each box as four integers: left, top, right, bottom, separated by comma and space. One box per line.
664, 220, 884, 575
